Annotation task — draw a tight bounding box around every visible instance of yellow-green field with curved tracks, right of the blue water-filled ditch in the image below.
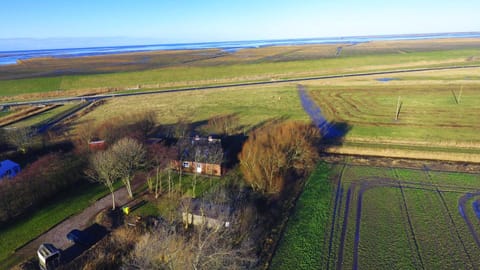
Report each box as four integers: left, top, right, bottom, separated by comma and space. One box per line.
306, 68, 480, 162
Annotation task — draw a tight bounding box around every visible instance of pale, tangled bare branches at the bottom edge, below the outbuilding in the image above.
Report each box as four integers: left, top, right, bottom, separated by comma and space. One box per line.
125, 206, 257, 270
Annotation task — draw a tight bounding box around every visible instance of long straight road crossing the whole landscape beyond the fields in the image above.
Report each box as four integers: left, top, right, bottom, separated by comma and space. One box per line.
0, 65, 480, 108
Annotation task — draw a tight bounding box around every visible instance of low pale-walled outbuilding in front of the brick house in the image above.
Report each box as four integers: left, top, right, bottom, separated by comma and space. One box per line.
181, 199, 233, 228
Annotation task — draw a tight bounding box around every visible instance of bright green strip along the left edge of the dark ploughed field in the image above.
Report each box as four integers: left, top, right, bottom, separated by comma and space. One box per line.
270, 164, 333, 269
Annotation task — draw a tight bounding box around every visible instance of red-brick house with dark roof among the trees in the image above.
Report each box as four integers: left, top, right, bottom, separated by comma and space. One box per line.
172, 136, 223, 176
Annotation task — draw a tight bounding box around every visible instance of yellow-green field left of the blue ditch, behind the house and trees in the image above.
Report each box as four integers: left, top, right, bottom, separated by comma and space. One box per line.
78, 85, 308, 132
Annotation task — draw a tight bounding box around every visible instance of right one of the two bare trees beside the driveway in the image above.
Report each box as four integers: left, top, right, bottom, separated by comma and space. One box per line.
109, 137, 146, 198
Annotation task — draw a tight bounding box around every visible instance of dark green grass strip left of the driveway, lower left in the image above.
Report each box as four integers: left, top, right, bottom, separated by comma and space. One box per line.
0, 180, 109, 269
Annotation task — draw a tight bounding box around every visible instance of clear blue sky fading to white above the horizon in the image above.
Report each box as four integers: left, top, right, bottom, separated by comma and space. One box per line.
0, 0, 480, 49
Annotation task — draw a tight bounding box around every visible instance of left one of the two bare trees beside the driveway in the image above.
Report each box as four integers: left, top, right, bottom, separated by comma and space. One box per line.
86, 151, 119, 210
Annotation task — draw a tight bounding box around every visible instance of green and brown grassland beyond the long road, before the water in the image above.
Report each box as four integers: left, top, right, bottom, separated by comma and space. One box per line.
0, 39, 480, 101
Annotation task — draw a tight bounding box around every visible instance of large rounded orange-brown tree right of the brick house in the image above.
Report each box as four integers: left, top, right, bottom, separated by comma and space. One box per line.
239, 122, 320, 194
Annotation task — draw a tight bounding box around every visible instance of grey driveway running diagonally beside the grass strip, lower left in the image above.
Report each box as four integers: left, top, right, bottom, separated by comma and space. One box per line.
13, 188, 130, 259
